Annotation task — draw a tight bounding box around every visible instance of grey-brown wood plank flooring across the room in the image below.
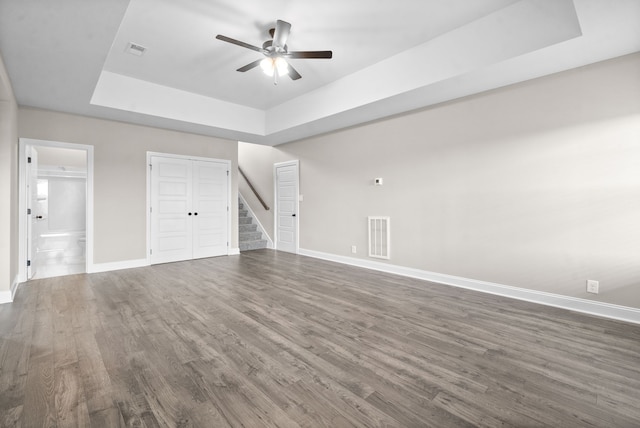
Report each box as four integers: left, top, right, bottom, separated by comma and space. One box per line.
0, 250, 640, 427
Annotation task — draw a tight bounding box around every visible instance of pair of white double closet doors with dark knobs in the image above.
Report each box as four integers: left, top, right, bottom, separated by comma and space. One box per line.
151, 156, 229, 264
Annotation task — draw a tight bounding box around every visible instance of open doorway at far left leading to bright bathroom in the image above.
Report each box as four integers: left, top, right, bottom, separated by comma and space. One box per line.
20, 139, 92, 281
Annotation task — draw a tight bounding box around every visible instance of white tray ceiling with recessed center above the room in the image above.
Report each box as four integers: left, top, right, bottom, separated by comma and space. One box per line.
0, 0, 640, 145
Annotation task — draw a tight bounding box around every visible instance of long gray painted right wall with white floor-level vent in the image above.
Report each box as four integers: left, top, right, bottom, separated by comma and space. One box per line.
238, 54, 640, 308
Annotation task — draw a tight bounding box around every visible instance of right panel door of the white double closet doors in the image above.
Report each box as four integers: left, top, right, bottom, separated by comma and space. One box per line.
191, 161, 229, 259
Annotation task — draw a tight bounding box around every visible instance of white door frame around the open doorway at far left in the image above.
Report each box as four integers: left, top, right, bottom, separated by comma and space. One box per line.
18, 138, 94, 283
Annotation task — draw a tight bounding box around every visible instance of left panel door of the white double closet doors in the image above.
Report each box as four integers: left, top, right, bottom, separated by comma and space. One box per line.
151, 156, 194, 264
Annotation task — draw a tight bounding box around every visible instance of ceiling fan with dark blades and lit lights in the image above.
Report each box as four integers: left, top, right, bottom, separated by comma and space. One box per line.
216, 20, 333, 85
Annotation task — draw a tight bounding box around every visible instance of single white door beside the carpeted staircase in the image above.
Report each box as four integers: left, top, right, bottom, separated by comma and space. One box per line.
275, 161, 298, 253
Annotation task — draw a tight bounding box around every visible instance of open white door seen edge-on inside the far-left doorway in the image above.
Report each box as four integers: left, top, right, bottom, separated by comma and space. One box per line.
26, 146, 39, 279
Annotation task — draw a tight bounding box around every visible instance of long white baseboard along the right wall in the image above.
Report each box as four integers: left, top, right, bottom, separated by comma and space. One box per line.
298, 248, 640, 324
